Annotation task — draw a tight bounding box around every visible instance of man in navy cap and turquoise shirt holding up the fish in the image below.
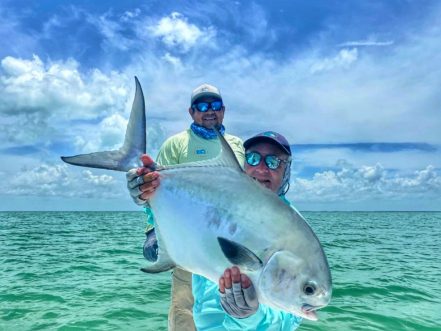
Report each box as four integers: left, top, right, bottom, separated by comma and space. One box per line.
128, 124, 301, 331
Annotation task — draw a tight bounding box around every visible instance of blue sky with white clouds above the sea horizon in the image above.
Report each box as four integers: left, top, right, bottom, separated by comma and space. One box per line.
0, 0, 441, 211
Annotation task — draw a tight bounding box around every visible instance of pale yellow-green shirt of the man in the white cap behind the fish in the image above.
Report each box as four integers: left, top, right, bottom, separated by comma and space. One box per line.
146, 129, 245, 232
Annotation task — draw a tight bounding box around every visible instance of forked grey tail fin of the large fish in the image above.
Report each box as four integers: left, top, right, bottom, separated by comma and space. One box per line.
61, 77, 146, 171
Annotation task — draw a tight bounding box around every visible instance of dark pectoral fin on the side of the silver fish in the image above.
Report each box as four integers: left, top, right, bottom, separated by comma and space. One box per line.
217, 237, 262, 270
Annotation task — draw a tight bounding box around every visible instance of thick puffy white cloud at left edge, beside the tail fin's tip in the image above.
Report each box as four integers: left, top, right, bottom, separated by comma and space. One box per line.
0, 55, 127, 119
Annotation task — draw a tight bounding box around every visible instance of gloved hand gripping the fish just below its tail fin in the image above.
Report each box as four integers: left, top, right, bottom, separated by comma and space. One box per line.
126, 154, 159, 206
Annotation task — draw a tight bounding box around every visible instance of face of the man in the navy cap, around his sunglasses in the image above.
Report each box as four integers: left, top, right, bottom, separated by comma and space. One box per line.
245, 142, 288, 193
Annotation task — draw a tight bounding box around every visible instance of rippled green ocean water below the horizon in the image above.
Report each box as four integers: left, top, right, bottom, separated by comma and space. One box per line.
0, 212, 441, 331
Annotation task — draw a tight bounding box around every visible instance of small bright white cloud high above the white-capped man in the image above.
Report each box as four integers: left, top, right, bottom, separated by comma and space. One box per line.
148, 12, 216, 53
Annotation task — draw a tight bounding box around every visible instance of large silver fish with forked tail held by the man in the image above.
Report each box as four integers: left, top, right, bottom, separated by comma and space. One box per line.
62, 77, 332, 320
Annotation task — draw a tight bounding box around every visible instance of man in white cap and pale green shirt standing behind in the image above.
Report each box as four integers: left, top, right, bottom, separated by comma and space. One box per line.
127, 84, 245, 331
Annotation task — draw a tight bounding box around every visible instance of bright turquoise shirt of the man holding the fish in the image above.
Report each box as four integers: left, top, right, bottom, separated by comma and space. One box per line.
192, 196, 302, 331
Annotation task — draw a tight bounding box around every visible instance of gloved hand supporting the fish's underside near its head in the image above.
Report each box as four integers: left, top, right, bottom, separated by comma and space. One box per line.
219, 267, 259, 318
